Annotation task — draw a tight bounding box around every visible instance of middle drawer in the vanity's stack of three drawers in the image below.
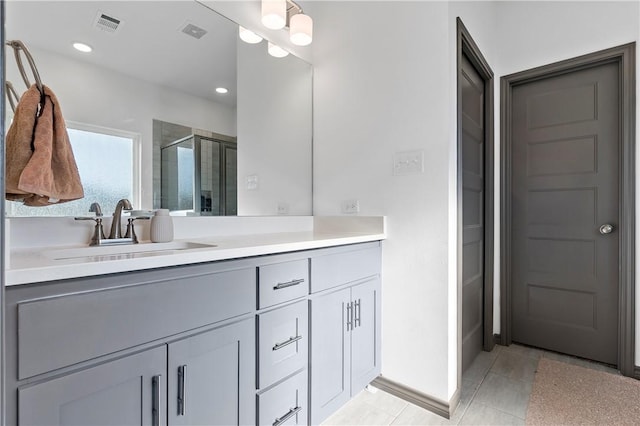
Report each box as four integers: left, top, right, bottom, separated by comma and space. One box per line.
257, 300, 309, 389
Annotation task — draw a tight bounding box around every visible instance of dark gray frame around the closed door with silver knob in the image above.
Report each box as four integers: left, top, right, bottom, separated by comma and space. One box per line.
500, 42, 636, 377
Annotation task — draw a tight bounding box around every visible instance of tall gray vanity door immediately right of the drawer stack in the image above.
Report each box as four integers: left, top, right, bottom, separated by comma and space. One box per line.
310, 288, 351, 425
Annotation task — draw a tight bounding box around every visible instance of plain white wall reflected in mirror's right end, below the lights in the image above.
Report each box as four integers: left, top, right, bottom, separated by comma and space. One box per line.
237, 41, 313, 216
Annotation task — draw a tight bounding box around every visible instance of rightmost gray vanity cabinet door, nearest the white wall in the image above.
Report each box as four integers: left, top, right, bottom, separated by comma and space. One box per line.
351, 277, 380, 395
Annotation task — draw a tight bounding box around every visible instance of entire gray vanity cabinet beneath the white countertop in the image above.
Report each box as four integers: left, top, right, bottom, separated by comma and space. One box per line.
5, 242, 381, 426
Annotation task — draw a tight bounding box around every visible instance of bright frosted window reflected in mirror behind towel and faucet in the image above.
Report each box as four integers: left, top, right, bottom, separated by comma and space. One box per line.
7, 128, 140, 216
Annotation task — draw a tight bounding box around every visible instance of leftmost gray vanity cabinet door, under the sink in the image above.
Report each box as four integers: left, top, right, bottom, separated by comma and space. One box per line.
18, 346, 167, 426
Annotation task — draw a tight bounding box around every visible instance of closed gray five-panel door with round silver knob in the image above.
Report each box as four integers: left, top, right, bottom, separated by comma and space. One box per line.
511, 63, 620, 364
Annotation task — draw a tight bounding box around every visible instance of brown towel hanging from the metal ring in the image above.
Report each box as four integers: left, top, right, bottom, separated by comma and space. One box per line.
6, 85, 84, 206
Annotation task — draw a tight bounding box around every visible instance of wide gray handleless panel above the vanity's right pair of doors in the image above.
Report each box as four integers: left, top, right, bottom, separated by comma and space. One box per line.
311, 244, 382, 293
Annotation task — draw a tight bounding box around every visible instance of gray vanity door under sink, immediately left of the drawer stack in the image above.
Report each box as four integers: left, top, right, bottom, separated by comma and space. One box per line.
168, 319, 256, 425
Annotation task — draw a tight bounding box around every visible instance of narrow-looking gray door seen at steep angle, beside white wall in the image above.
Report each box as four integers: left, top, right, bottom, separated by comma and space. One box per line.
458, 55, 484, 371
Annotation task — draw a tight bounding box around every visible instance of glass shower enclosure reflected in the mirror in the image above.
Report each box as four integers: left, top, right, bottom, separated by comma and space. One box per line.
160, 135, 238, 216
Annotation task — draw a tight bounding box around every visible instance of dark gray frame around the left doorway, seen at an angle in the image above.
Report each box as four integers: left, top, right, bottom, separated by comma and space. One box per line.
456, 17, 495, 382
